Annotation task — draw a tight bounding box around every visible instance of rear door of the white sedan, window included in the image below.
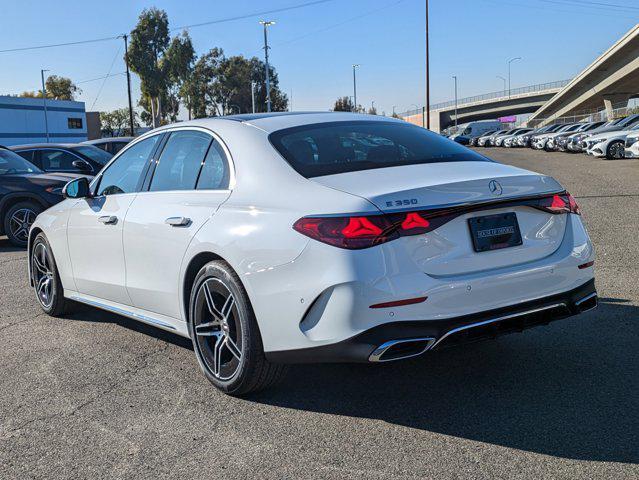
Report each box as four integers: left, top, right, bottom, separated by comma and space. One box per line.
124, 129, 231, 319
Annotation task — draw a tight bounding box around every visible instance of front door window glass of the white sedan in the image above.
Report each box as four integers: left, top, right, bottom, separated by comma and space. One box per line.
97, 135, 161, 195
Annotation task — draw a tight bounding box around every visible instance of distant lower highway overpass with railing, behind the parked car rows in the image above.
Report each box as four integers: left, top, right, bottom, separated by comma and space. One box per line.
400, 80, 569, 132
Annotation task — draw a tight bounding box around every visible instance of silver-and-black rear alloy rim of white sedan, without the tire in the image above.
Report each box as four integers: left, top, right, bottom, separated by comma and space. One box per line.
193, 278, 243, 380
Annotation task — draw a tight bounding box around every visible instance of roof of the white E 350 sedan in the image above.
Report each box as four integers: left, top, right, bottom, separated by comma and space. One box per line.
149, 112, 406, 134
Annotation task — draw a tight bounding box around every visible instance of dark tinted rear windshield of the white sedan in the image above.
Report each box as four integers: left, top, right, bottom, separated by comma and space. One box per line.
269, 121, 491, 178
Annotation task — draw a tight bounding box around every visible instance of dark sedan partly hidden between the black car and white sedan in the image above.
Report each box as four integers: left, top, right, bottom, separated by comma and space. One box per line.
8, 143, 113, 175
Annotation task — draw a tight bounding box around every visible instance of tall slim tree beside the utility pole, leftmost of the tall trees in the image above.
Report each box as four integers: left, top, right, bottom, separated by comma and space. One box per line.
128, 8, 169, 127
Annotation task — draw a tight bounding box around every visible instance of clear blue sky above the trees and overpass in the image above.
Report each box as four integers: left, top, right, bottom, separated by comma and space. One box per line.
0, 0, 639, 119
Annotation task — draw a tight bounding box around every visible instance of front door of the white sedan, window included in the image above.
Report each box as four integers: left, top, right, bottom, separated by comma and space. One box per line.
67, 134, 162, 305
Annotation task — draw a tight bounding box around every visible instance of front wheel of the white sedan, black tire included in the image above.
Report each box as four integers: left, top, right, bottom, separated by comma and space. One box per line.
29, 233, 73, 317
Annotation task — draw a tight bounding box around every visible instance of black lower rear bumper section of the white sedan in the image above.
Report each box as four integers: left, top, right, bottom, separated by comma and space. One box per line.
266, 279, 597, 363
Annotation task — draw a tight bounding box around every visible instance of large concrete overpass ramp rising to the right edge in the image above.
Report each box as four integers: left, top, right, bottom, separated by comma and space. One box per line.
528, 25, 639, 126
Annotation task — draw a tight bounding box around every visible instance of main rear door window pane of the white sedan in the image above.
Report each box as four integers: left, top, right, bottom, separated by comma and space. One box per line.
149, 130, 212, 192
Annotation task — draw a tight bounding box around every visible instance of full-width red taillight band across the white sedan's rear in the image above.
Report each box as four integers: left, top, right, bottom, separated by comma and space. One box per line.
293, 192, 580, 250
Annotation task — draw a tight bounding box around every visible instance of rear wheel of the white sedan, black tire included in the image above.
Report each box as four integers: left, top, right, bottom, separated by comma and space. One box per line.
188, 260, 286, 396
